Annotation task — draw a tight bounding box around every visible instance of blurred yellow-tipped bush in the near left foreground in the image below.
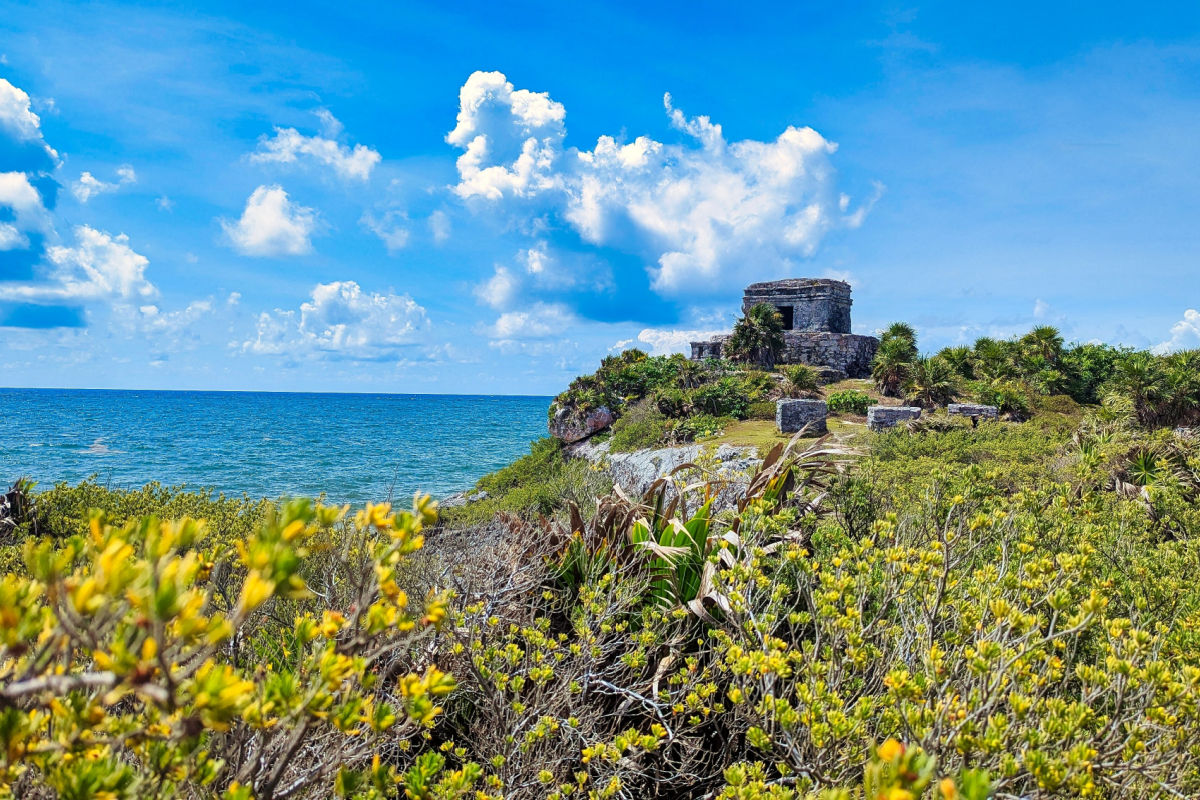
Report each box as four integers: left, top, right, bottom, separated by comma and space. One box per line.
0, 498, 455, 800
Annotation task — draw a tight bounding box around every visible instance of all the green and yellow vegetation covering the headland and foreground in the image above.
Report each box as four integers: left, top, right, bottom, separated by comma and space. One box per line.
0, 325, 1200, 800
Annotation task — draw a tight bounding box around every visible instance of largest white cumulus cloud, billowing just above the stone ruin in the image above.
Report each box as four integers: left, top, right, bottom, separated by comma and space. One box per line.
446, 72, 880, 296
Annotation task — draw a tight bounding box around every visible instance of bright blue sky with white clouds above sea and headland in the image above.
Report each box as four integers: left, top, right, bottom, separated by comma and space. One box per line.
0, 1, 1200, 393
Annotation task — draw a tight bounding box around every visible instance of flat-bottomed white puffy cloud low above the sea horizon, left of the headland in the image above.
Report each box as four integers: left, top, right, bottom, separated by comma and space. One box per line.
241, 281, 428, 360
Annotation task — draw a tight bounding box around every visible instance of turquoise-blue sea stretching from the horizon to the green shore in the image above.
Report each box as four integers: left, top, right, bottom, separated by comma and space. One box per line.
0, 389, 550, 504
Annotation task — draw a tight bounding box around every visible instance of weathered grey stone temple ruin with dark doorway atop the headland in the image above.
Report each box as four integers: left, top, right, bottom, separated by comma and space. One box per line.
691, 278, 880, 380
